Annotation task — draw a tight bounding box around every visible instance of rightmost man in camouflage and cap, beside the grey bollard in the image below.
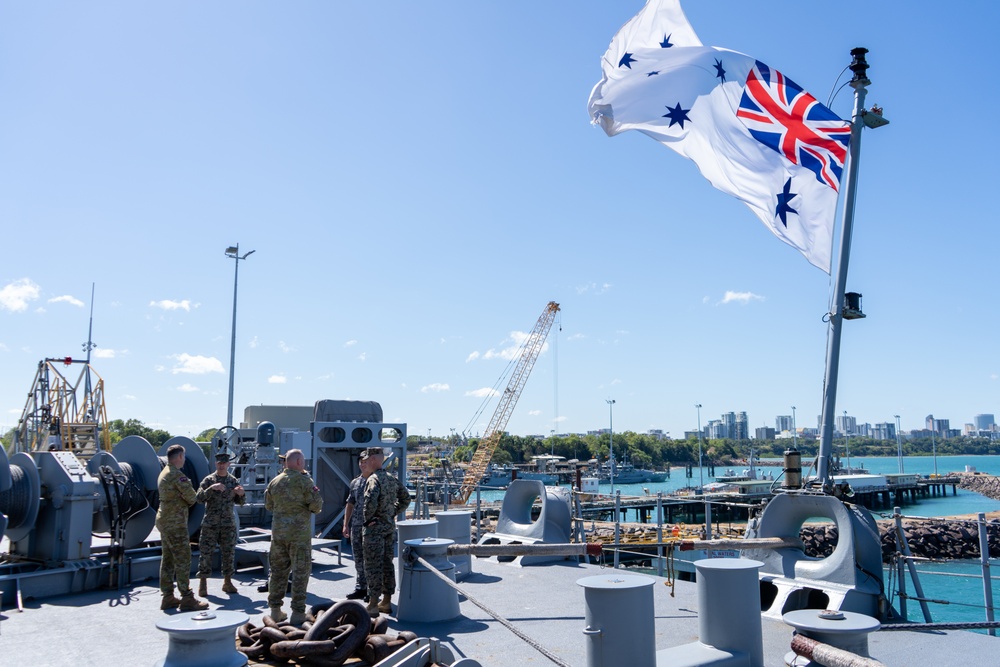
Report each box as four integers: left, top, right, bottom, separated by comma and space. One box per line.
362, 447, 410, 616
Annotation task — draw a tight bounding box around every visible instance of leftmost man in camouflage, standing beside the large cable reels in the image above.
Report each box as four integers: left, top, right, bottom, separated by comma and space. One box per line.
156, 445, 208, 611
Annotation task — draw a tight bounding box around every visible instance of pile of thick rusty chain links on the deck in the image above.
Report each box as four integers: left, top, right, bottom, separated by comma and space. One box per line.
236, 600, 417, 667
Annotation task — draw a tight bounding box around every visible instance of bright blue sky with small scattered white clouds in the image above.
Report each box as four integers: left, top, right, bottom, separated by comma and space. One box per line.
0, 0, 1000, 437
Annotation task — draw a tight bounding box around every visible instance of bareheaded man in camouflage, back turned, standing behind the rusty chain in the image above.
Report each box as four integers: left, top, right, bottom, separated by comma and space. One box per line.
264, 449, 323, 625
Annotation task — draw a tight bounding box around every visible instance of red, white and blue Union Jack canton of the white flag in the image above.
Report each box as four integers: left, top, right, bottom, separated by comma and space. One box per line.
736, 60, 851, 190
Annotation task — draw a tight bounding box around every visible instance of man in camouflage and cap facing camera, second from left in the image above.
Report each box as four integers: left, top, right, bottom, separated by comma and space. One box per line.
198, 452, 246, 597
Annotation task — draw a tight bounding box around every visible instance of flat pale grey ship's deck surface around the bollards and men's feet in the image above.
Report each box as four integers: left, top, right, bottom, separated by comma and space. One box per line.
0, 551, 1000, 667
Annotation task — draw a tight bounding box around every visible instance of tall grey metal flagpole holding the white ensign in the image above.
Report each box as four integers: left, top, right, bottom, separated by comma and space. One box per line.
816, 47, 871, 491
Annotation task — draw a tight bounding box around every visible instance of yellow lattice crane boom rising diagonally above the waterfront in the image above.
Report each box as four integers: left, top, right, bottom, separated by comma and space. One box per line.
456, 301, 559, 504
